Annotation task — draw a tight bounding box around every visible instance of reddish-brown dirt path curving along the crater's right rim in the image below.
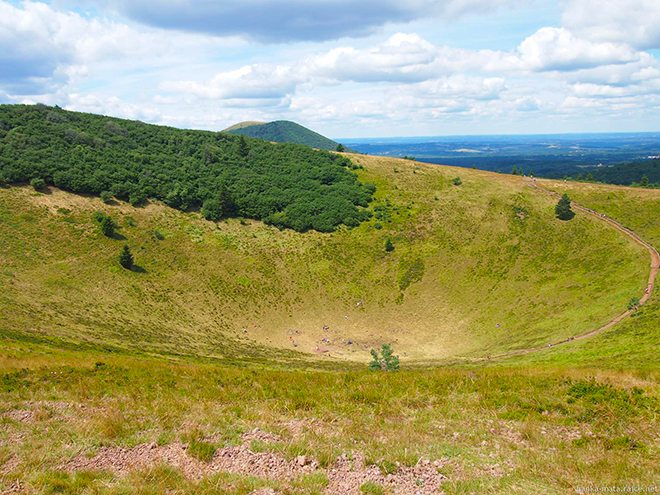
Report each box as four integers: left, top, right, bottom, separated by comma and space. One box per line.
472, 180, 660, 362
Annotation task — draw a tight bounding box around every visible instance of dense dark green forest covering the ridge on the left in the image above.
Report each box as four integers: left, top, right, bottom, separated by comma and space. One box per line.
0, 105, 375, 232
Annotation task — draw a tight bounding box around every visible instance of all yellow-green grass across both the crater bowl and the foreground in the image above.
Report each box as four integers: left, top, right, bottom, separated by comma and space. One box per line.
0, 157, 660, 494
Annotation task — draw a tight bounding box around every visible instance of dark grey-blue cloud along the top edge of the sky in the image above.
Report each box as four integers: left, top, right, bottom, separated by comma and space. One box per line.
98, 0, 520, 42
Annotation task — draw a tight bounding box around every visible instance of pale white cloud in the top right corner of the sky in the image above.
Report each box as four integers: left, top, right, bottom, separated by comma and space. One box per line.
562, 0, 660, 50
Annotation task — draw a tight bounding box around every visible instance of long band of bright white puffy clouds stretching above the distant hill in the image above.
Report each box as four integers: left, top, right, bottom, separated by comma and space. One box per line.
161, 28, 641, 107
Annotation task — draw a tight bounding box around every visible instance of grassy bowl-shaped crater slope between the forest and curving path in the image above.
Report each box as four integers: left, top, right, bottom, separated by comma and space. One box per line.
0, 156, 648, 363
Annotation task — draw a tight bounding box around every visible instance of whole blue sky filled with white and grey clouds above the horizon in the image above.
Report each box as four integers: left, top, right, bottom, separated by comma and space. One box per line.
0, 0, 660, 138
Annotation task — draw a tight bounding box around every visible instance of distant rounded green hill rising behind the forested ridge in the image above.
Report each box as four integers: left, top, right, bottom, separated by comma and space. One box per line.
225, 120, 353, 151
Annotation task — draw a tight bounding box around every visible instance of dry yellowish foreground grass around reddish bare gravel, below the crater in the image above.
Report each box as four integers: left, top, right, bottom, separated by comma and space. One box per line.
0, 355, 660, 493
